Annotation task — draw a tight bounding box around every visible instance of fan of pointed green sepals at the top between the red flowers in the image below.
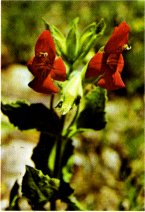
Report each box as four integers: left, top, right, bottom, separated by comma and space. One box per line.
44, 18, 106, 65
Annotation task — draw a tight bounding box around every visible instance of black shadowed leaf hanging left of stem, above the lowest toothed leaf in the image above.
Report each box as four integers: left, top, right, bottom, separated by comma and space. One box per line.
31, 133, 56, 176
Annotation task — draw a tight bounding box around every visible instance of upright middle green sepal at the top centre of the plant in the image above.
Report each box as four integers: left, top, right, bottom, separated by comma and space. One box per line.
66, 18, 79, 63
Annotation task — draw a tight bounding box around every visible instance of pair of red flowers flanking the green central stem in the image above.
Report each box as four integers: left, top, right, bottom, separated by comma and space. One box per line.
28, 21, 130, 94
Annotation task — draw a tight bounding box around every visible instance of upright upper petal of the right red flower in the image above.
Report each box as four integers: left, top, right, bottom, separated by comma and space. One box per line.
104, 21, 130, 53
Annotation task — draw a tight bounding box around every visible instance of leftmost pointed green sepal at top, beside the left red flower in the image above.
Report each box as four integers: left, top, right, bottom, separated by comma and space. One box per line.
43, 19, 67, 59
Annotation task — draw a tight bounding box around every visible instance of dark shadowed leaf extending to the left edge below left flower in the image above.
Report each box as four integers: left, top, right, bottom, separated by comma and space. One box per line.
1, 101, 60, 134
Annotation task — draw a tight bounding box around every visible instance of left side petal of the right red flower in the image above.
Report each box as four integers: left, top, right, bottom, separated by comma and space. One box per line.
86, 52, 104, 78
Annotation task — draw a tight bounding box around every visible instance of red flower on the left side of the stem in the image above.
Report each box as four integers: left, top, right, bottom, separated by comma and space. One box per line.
27, 30, 66, 94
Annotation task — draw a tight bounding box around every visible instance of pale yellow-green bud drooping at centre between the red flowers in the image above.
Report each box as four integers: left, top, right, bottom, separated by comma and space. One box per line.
59, 72, 83, 115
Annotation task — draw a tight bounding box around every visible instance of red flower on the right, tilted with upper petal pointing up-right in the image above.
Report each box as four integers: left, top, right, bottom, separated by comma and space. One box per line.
86, 21, 130, 90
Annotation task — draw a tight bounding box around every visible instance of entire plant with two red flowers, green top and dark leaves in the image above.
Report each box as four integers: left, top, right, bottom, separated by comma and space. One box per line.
2, 18, 130, 210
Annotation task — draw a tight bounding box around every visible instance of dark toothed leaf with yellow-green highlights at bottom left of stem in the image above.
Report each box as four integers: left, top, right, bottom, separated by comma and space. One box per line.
22, 166, 60, 208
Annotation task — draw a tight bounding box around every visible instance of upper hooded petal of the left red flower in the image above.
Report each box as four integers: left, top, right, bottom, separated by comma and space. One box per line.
35, 30, 56, 64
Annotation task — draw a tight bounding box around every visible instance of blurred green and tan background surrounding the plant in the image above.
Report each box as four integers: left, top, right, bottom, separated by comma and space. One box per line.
1, 0, 144, 211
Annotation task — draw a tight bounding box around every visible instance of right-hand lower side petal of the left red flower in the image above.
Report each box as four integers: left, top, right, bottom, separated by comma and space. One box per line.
51, 57, 66, 81
